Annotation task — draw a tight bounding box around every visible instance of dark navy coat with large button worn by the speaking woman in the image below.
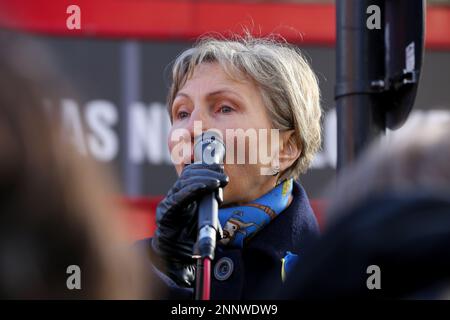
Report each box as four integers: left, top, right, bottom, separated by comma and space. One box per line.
137, 182, 319, 299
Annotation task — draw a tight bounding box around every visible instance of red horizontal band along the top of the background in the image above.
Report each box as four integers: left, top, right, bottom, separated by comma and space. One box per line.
0, 0, 450, 49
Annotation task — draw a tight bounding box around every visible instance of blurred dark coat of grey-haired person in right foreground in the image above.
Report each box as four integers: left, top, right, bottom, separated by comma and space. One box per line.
281, 190, 450, 299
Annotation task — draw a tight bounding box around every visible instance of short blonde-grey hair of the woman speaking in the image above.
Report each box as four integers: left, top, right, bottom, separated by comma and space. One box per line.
167, 34, 322, 179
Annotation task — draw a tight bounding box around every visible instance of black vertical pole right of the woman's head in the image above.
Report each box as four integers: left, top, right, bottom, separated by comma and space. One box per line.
335, 0, 385, 170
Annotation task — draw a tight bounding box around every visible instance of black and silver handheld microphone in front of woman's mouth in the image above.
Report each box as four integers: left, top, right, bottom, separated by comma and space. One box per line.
194, 130, 225, 260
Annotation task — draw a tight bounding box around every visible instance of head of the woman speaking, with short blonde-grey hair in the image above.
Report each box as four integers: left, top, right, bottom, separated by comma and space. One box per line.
167, 36, 321, 203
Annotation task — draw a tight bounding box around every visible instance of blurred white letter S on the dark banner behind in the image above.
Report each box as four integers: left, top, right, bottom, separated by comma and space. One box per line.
86, 100, 119, 161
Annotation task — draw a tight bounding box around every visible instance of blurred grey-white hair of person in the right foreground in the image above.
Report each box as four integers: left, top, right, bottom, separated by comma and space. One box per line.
329, 119, 450, 225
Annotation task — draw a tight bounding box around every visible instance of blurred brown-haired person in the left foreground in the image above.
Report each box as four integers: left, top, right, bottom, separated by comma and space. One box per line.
0, 39, 149, 299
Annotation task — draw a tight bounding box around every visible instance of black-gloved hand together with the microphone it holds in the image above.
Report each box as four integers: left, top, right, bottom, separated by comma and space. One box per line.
152, 131, 228, 287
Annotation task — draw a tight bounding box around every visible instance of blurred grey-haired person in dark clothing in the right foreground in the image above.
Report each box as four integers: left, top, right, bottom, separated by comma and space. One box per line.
280, 120, 450, 299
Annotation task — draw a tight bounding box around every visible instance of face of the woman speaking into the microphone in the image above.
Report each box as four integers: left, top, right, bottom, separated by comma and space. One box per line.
169, 63, 276, 205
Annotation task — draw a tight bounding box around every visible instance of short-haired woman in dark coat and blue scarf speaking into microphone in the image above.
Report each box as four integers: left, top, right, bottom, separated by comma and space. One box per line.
145, 36, 321, 299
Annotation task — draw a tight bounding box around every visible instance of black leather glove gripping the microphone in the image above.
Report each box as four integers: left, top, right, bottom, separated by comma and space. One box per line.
152, 164, 228, 287
